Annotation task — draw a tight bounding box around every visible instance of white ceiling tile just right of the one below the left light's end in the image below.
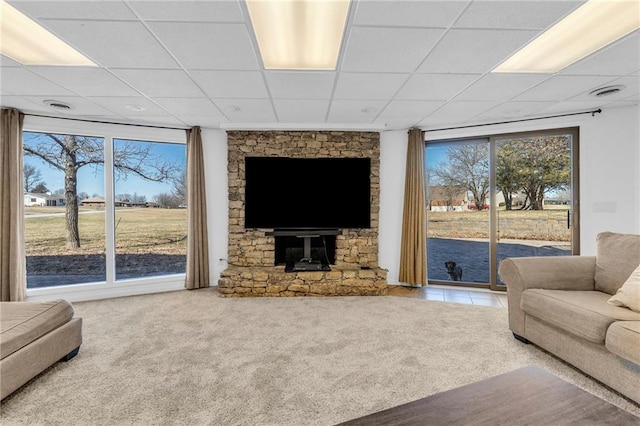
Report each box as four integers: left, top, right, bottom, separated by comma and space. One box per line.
111, 69, 203, 98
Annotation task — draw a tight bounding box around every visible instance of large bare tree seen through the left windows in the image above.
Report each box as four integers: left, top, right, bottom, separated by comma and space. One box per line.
23, 133, 174, 248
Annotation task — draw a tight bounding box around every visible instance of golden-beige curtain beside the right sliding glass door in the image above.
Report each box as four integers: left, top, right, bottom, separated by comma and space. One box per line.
399, 129, 427, 286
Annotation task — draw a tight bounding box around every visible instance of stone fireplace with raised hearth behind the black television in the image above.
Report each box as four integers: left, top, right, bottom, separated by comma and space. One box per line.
218, 131, 387, 297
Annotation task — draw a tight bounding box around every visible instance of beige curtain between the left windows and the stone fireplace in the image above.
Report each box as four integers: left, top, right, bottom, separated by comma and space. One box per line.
185, 127, 209, 289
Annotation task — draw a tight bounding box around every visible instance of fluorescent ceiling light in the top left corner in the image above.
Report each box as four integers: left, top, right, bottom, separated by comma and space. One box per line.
0, 0, 96, 66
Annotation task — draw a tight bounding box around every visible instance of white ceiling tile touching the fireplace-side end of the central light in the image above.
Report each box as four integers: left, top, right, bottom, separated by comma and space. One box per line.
265, 71, 336, 99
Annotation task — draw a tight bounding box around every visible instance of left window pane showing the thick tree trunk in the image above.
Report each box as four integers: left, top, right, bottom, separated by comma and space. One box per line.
23, 132, 106, 288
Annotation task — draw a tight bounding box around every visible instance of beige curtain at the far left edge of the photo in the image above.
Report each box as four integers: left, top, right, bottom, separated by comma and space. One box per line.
0, 109, 27, 302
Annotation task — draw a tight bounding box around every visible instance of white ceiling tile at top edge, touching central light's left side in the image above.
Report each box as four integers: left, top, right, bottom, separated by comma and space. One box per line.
129, 0, 244, 22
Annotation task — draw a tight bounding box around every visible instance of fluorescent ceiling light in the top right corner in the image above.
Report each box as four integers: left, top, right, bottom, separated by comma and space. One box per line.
493, 0, 640, 73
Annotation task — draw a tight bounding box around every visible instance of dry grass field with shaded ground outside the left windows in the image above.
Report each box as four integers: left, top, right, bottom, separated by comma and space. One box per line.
25, 207, 187, 278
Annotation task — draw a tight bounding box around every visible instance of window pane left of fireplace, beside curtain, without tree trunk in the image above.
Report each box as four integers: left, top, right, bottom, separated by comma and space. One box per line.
114, 139, 187, 279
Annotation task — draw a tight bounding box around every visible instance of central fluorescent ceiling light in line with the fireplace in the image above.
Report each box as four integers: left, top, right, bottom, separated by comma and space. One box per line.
246, 0, 349, 70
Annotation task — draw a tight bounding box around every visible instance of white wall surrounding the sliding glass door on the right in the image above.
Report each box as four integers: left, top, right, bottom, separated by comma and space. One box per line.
379, 105, 640, 283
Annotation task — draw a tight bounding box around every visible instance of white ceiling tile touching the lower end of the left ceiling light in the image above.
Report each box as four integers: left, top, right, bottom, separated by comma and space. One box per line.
33, 67, 140, 96
